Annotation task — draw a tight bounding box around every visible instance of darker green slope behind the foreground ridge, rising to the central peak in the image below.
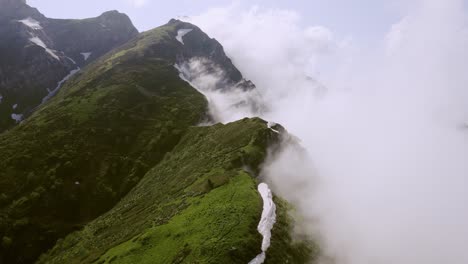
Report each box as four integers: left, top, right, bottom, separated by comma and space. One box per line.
0, 21, 207, 263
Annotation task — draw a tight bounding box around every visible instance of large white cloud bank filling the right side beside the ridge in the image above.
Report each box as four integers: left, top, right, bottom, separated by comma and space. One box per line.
186, 0, 468, 264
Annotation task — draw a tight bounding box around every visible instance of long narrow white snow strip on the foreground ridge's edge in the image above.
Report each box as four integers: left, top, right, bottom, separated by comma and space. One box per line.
249, 183, 276, 264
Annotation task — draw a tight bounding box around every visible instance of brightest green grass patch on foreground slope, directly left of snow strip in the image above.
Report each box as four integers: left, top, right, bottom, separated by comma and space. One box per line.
97, 172, 262, 264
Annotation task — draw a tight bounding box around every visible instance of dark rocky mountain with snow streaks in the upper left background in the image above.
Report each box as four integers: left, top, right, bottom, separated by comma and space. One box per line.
0, 0, 138, 132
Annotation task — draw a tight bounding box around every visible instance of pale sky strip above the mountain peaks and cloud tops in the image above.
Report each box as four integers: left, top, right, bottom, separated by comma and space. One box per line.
28, 0, 401, 38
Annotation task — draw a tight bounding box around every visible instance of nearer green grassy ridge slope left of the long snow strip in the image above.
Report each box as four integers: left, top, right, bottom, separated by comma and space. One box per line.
42, 119, 273, 263
